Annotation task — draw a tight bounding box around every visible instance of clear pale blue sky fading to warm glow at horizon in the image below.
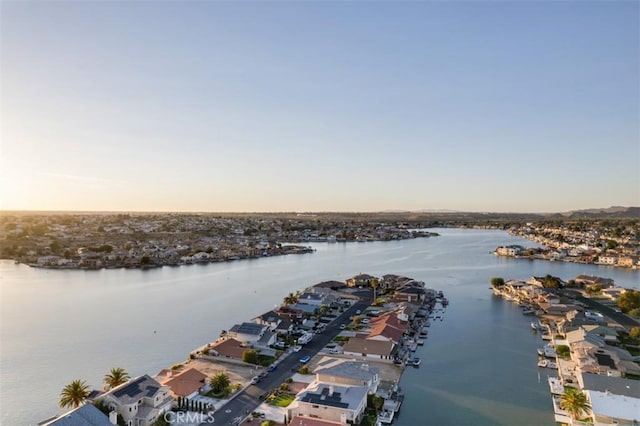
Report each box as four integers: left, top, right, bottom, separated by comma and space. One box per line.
0, 1, 640, 212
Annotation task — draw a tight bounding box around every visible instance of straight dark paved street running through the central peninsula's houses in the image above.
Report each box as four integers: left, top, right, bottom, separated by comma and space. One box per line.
202, 290, 373, 426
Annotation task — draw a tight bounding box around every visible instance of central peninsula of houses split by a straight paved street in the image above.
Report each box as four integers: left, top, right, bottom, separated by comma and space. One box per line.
40, 274, 448, 426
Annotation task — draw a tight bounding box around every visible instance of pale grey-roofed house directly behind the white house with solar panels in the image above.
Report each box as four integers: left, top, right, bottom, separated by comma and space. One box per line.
314, 357, 380, 394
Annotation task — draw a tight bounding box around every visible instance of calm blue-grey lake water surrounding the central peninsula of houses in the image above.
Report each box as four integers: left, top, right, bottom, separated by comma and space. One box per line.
0, 229, 640, 425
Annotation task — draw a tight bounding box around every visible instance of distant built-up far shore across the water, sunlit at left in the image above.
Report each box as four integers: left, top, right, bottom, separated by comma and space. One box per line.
0, 213, 437, 269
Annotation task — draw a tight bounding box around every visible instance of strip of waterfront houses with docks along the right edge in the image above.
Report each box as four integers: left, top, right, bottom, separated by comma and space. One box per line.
492, 275, 640, 426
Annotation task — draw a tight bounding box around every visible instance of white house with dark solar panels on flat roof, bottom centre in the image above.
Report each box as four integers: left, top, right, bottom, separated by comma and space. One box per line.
287, 382, 368, 424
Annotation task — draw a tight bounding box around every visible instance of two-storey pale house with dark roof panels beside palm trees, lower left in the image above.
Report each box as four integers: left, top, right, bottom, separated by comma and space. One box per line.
97, 374, 173, 426
